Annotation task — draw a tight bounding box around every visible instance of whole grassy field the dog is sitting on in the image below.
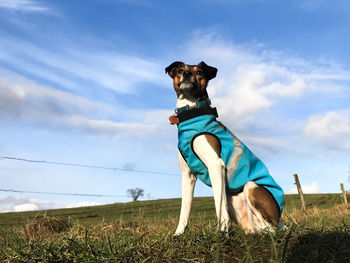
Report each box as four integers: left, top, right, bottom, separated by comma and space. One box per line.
0, 194, 350, 262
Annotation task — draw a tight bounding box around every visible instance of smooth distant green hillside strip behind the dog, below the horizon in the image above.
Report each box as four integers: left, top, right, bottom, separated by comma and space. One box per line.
0, 194, 342, 228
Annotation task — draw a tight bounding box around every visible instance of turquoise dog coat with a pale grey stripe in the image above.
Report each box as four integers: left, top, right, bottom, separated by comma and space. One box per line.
178, 111, 284, 213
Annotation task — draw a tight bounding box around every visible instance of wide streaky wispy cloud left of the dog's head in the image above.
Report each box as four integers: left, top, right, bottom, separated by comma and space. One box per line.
0, 37, 164, 93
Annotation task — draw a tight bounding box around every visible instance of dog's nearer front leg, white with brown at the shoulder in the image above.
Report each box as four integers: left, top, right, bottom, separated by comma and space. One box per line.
193, 135, 230, 231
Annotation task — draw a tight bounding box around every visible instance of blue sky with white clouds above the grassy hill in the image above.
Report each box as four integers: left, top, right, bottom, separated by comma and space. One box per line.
0, 0, 350, 212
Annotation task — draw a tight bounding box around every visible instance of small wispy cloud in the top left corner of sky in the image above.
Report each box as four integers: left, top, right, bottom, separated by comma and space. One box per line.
0, 0, 50, 12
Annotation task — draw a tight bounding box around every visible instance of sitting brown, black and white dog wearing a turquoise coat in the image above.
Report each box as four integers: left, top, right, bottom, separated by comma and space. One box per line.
165, 61, 284, 235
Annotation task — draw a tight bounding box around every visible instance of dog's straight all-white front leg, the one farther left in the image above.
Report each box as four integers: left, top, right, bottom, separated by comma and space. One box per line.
174, 151, 197, 236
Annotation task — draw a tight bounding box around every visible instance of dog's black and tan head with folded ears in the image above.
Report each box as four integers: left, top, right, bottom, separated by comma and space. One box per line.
165, 61, 218, 98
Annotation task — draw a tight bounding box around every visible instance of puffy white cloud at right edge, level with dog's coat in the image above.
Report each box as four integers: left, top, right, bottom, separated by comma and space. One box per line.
304, 110, 350, 151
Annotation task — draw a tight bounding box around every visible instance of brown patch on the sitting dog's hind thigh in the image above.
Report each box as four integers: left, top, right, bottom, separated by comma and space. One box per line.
248, 185, 280, 226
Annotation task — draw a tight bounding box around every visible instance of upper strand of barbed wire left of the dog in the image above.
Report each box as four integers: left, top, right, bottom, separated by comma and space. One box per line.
0, 156, 180, 176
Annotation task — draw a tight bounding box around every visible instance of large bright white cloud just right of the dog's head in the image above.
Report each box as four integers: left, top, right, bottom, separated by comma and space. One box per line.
180, 34, 350, 121
